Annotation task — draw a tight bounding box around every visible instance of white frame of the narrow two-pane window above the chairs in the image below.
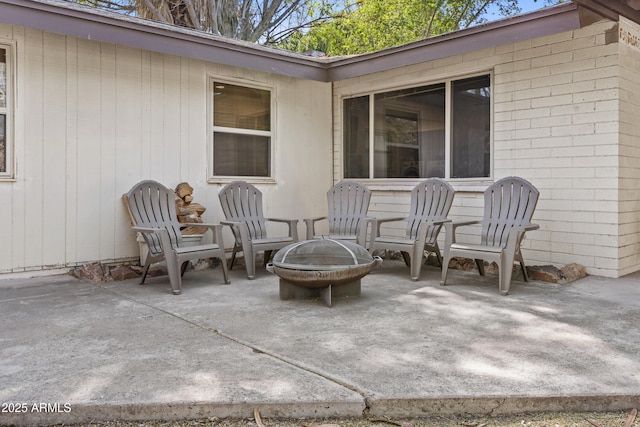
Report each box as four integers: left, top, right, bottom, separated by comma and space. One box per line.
207, 75, 276, 184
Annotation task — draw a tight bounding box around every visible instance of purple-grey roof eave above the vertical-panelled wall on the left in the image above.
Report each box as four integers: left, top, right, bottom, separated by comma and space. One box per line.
0, 0, 327, 81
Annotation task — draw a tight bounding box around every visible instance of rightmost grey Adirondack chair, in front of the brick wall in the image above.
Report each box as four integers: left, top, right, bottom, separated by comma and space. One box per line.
440, 176, 540, 295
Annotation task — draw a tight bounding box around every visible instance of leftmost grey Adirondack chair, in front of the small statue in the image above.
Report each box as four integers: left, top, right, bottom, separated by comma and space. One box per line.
123, 180, 229, 295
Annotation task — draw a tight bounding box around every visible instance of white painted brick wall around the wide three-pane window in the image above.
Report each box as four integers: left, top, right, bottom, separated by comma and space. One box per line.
333, 20, 640, 277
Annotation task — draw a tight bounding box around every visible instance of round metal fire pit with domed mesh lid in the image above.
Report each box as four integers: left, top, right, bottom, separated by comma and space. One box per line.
267, 239, 382, 307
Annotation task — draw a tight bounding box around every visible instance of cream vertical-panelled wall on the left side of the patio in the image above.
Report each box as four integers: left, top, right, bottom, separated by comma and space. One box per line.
0, 24, 332, 273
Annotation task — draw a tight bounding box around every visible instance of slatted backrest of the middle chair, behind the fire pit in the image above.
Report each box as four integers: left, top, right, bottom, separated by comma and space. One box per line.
327, 181, 371, 235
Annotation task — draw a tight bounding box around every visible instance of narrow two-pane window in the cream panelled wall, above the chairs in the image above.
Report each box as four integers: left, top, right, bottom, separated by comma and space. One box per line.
212, 81, 271, 177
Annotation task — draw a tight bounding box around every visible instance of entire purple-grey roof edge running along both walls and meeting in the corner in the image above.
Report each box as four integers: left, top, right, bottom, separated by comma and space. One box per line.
0, 0, 600, 82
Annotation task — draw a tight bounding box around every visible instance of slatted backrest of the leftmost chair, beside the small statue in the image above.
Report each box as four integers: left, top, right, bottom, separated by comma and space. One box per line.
125, 180, 182, 255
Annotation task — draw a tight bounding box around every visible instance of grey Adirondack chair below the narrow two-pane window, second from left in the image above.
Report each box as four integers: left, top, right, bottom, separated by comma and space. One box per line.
218, 181, 298, 279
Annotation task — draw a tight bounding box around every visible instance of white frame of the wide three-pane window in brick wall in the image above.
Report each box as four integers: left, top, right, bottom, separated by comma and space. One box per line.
338, 70, 495, 185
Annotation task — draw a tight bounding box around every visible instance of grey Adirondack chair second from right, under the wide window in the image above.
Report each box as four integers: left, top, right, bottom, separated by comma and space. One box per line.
371, 178, 455, 280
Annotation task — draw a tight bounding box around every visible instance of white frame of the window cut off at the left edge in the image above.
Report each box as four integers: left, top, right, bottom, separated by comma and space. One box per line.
0, 39, 16, 181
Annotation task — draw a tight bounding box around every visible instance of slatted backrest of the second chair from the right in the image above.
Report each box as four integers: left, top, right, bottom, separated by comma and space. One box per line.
406, 178, 455, 245
